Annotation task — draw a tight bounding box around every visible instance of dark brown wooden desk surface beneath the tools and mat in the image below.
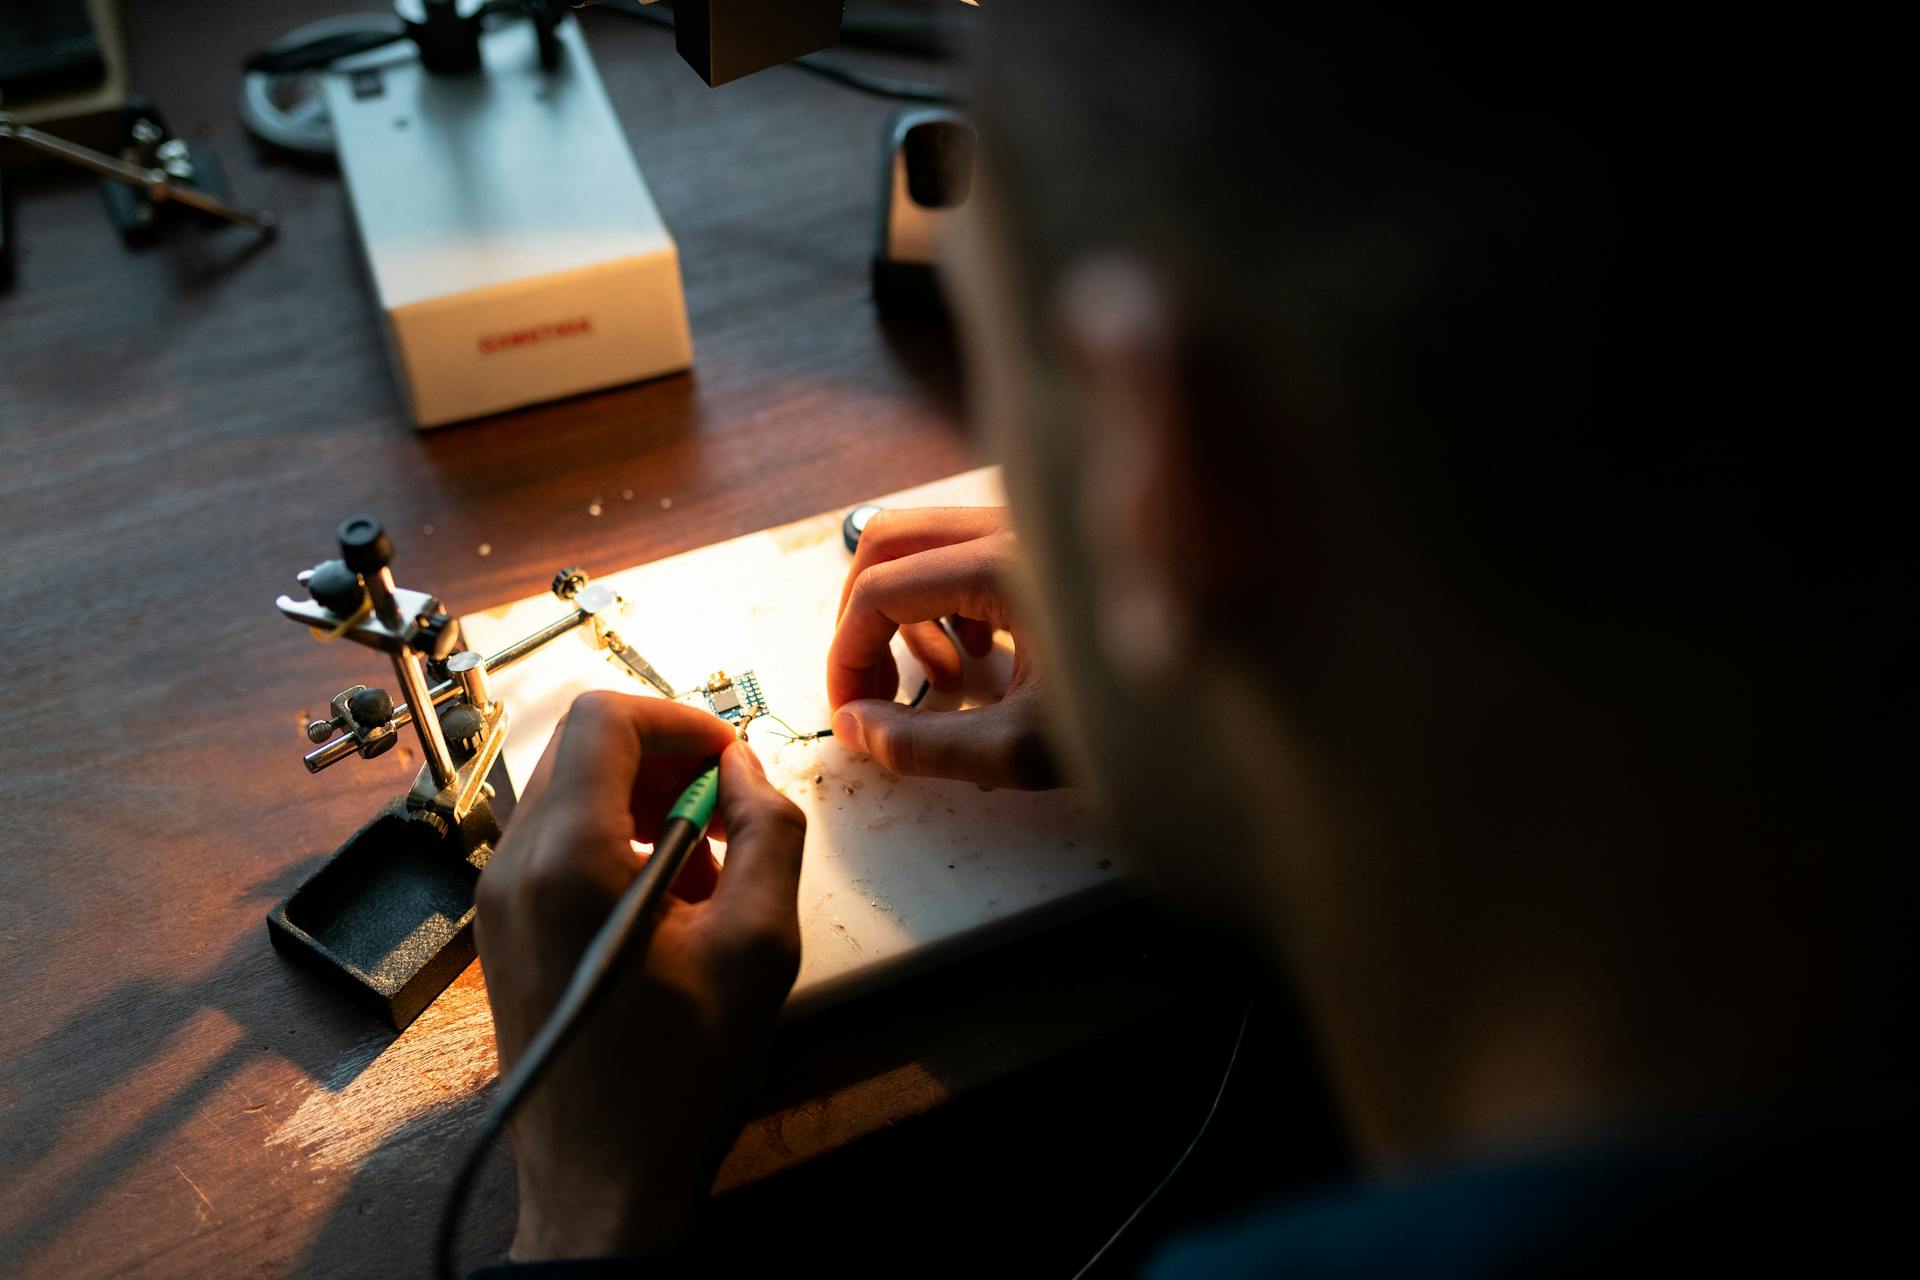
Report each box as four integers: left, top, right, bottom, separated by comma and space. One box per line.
0, 0, 1259, 1276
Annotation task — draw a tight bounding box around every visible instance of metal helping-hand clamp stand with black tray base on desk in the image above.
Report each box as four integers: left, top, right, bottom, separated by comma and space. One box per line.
267, 516, 672, 1029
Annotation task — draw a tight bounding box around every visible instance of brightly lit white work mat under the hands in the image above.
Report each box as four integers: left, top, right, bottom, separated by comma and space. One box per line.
461, 468, 1119, 1015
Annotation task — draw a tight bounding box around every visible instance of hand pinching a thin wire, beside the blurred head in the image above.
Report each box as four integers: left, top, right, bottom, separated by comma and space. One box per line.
828, 507, 1058, 789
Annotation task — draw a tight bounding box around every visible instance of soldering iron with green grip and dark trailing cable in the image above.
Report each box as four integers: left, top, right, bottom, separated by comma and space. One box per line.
436, 760, 720, 1280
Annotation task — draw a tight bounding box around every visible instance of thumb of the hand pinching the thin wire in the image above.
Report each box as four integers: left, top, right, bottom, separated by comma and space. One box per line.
833, 699, 1060, 789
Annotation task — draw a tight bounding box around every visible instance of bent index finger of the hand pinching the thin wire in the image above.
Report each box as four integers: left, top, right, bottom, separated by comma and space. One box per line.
828, 535, 1012, 706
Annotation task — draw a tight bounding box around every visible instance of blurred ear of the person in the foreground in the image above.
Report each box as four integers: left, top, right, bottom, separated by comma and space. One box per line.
1056, 255, 1204, 681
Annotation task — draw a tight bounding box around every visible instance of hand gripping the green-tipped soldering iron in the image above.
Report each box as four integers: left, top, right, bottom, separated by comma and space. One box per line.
476, 693, 806, 1261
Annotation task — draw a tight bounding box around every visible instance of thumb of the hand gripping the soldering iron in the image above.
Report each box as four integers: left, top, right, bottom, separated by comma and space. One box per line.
708, 743, 806, 948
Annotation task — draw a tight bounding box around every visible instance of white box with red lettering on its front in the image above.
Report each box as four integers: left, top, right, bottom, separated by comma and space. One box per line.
326, 21, 693, 426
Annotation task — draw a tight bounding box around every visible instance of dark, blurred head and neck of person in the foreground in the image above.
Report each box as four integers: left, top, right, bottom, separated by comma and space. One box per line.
952, 0, 1895, 1142
